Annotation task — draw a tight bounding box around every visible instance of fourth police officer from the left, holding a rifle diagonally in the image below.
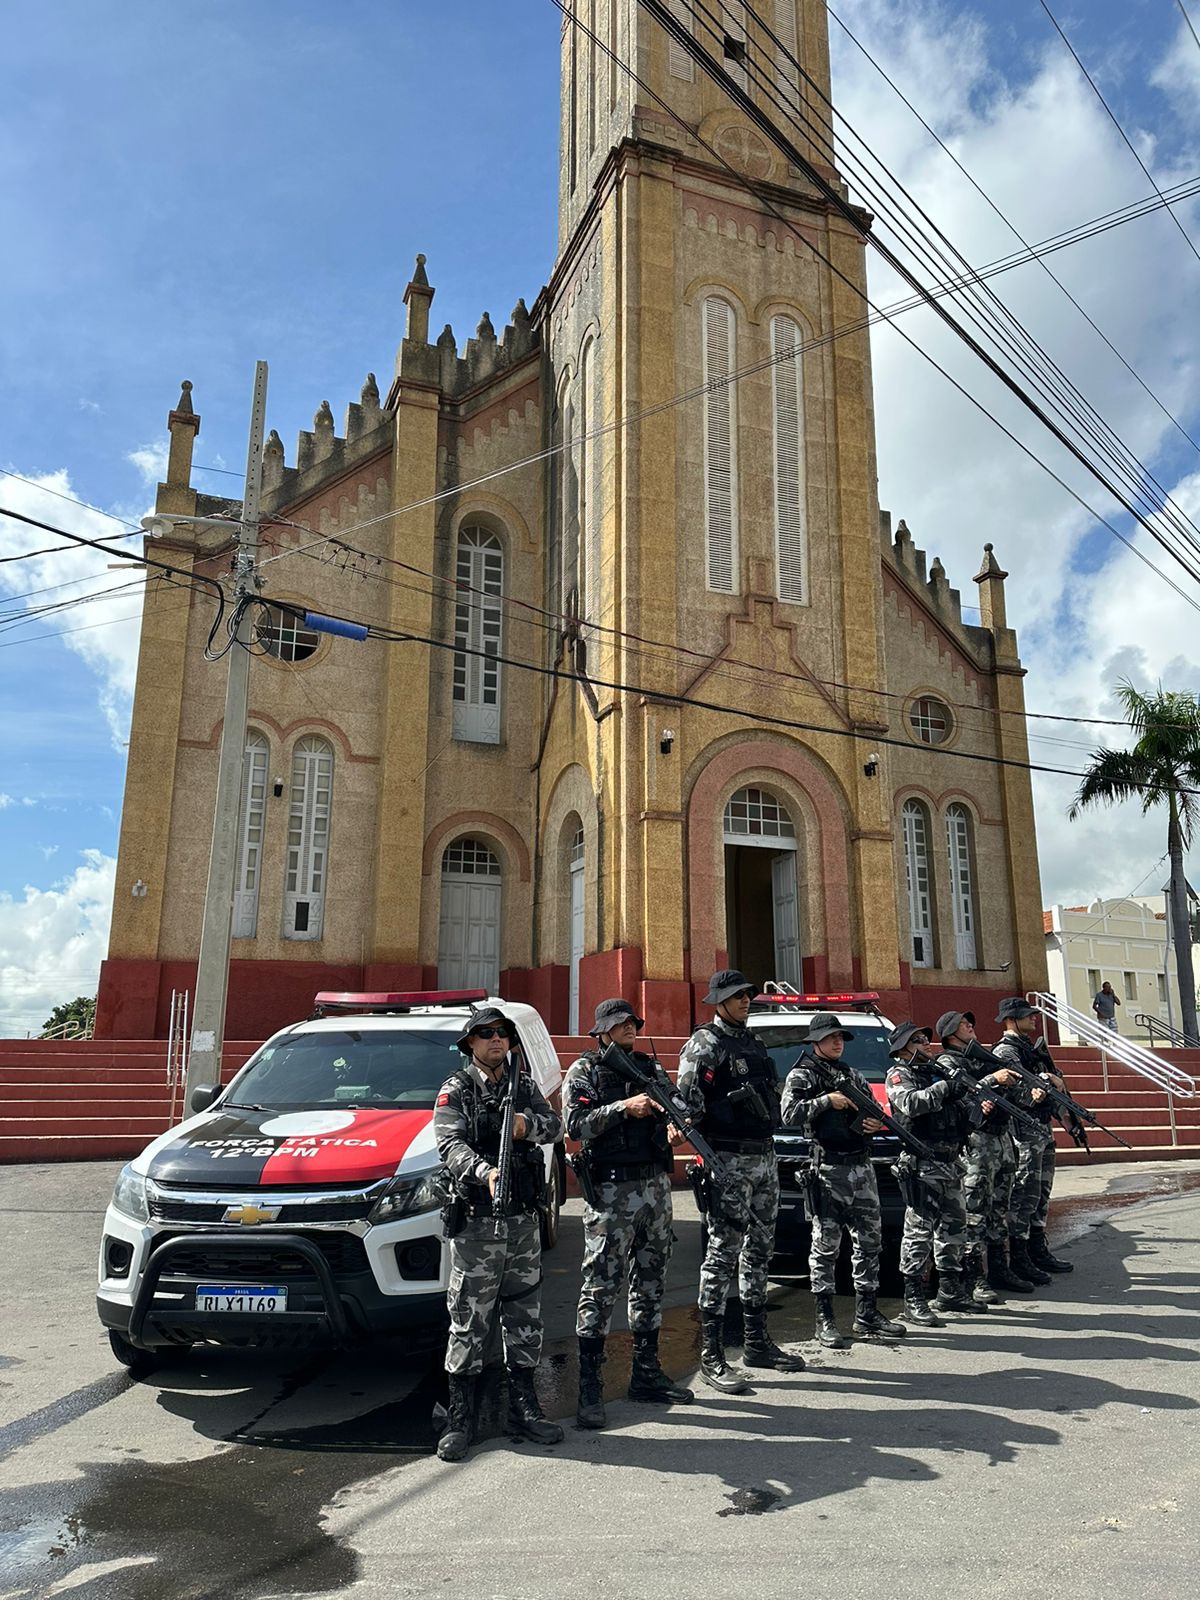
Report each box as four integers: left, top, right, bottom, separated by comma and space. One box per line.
782, 1011, 907, 1350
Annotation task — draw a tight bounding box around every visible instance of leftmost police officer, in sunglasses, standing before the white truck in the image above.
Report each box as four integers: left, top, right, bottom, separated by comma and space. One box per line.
434, 1006, 563, 1461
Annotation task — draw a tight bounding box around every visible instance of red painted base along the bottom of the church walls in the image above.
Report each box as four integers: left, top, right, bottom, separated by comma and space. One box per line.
96, 949, 1014, 1040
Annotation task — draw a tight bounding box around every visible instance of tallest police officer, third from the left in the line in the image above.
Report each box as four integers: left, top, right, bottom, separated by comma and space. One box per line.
678, 970, 805, 1395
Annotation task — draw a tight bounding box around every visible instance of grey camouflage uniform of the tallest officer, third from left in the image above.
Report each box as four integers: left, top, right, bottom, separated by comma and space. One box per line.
678, 1016, 779, 1314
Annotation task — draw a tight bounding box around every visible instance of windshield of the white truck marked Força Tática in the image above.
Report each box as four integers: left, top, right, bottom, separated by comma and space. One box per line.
226, 1027, 462, 1110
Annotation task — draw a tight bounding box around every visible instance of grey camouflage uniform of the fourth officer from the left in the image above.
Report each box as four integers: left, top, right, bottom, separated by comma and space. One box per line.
782, 1054, 883, 1294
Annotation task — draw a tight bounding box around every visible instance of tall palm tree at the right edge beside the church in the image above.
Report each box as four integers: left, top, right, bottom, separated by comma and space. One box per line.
1067, 682, 1200, 1038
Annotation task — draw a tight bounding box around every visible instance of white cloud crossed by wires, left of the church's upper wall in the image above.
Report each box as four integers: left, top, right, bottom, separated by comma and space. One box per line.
0, 470, 150, 748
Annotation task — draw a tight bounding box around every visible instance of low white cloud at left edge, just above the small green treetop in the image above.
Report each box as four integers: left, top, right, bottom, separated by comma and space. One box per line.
0, 850, 117, 1038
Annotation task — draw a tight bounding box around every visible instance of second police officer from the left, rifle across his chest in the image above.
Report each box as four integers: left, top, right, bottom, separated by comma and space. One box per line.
563, 1000, 693, 1427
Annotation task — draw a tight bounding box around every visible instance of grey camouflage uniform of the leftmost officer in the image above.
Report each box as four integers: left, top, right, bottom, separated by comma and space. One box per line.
434, 1061, 563, 1378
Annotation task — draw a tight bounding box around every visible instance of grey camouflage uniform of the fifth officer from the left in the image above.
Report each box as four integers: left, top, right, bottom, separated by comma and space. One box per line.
888, 1058, 966, 1278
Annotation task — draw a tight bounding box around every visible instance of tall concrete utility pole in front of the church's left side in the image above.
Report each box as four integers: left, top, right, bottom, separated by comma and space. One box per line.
184, 362, 267, 1107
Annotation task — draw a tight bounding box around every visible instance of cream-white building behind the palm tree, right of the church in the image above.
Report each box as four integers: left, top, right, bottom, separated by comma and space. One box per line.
1043, 899, 1181, 1040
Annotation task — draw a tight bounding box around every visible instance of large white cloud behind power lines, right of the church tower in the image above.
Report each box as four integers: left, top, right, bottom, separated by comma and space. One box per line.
832, 0, 1200, 904
